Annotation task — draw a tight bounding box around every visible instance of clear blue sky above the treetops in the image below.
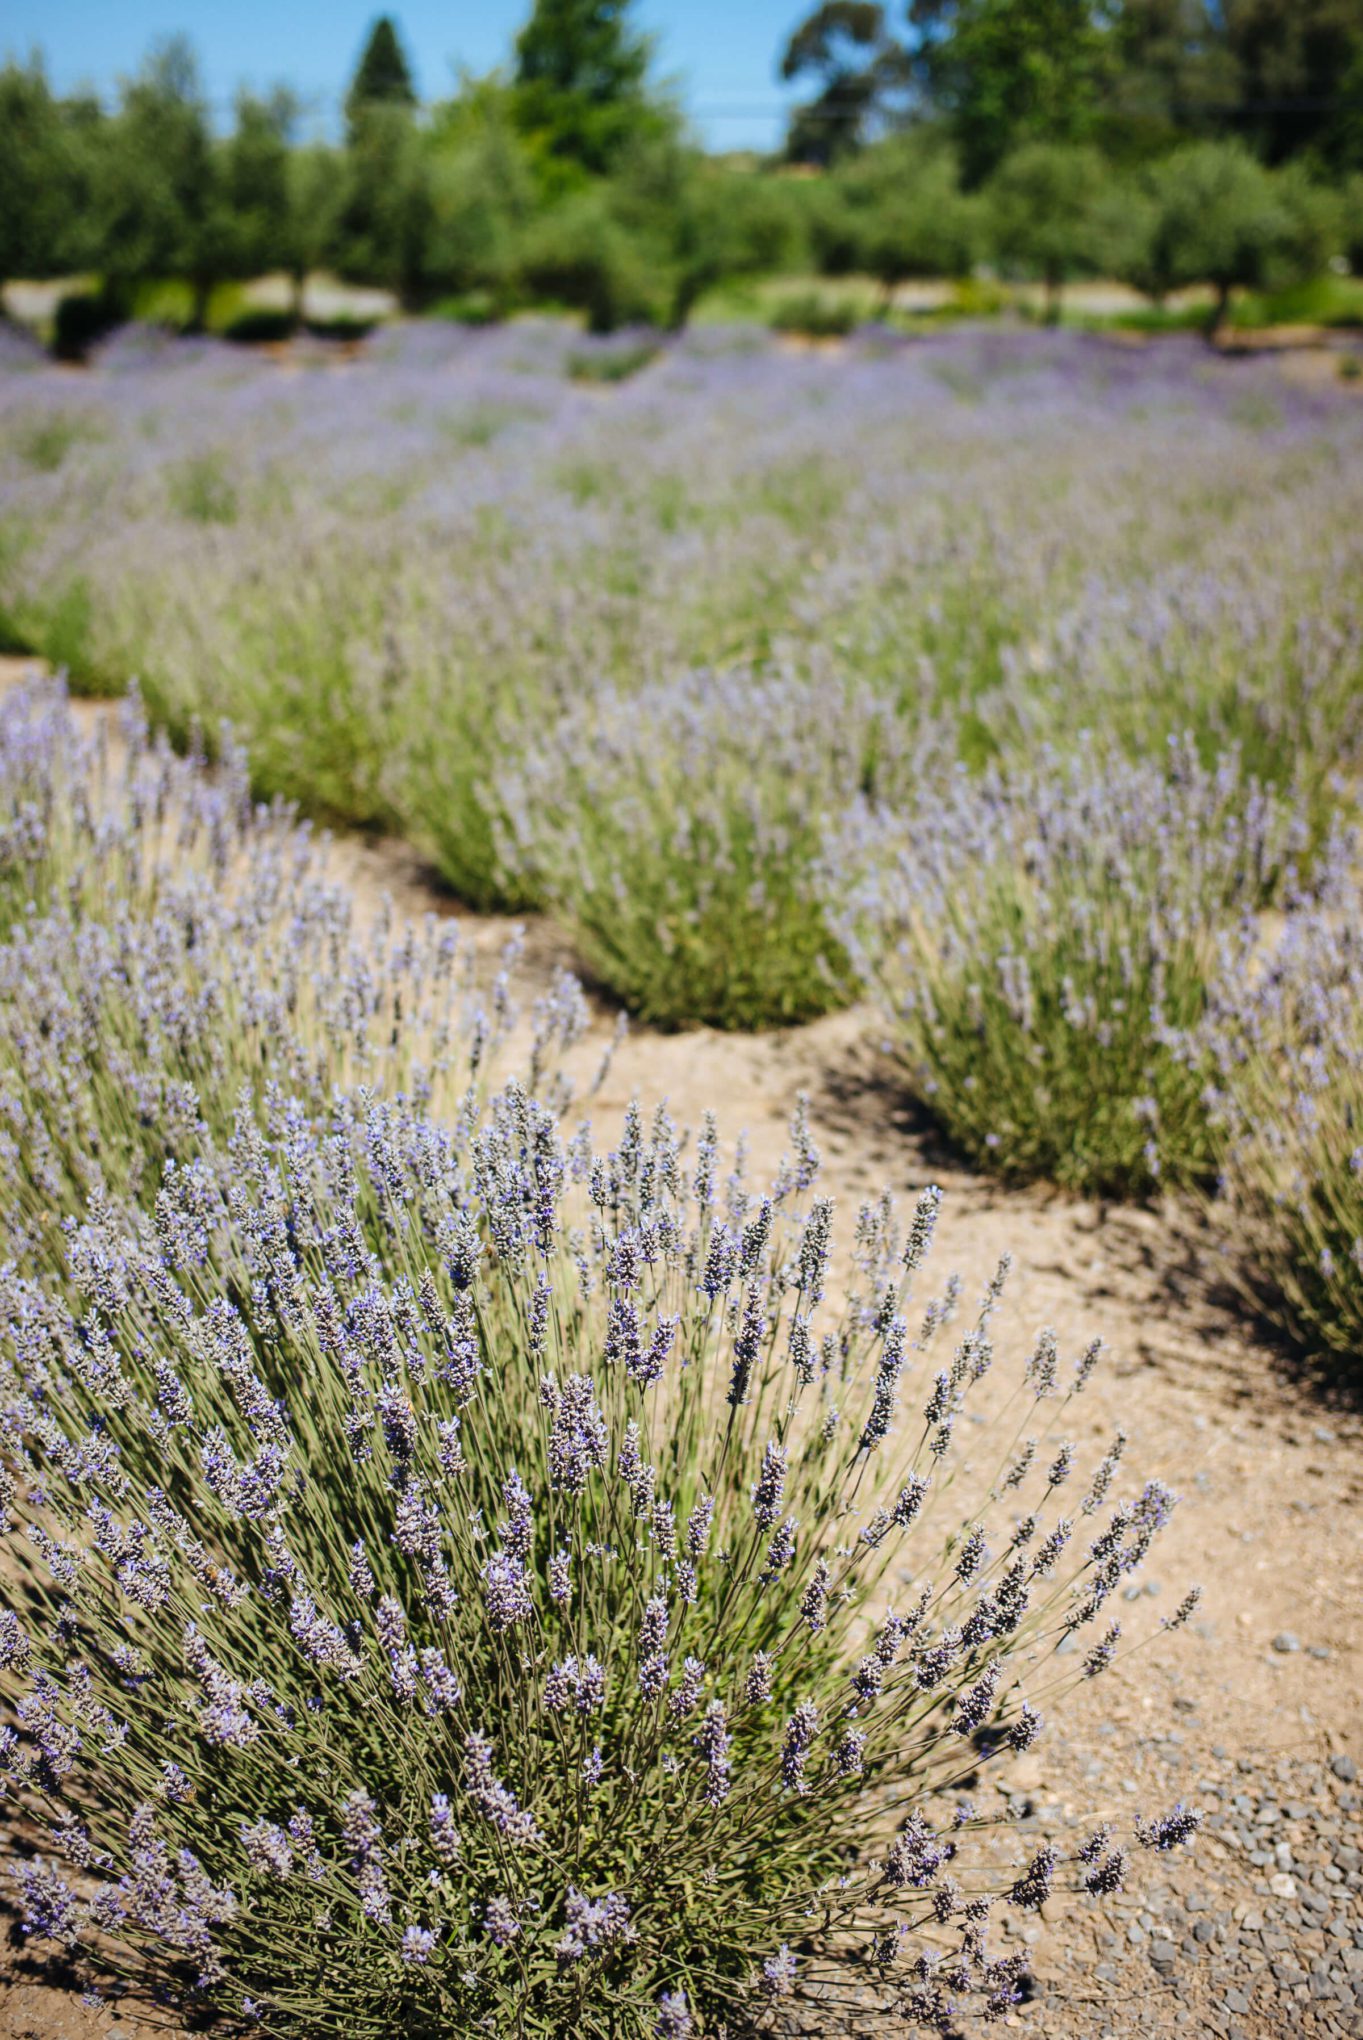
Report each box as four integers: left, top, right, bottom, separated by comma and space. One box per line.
0, 0, 808, 147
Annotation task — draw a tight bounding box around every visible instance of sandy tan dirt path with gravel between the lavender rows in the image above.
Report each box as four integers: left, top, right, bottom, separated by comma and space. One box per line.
0, 661, 1363, 2040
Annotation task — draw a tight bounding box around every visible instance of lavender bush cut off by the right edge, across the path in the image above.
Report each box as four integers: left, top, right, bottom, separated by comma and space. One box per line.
1208, 832, 1363, 1367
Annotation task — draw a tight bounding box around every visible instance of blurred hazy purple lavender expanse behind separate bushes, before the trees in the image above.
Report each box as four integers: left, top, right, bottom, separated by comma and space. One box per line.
0, 320, 1363, 926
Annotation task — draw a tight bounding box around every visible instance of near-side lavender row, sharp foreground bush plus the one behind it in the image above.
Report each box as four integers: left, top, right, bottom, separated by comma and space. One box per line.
0, 690, 1196, 2040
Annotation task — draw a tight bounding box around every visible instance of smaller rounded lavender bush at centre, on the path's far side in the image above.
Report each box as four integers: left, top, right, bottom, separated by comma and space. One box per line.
500, 671, 946, 1028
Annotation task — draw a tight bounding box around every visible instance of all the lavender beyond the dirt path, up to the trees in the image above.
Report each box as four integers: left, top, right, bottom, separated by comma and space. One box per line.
0, 324, 1363, 1355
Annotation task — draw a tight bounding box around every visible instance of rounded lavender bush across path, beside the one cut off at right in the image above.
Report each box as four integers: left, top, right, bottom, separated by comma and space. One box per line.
830, 741, 1306, 1195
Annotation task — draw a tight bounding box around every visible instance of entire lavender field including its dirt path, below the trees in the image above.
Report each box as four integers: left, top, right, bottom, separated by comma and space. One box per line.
0, 320, 1363, 2040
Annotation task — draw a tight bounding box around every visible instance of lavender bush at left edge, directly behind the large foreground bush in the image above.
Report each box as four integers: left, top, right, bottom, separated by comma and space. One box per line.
0, 683, 586, 1255
